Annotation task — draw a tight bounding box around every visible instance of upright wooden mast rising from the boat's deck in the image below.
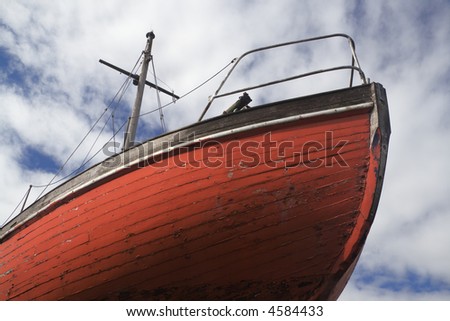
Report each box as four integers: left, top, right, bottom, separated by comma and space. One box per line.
123, 31, 155, 150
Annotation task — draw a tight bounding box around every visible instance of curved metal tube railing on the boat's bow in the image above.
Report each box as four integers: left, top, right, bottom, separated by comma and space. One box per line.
198, 33, 367, 121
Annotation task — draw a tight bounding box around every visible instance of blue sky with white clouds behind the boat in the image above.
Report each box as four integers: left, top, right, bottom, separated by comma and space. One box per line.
0, 0, 450, 300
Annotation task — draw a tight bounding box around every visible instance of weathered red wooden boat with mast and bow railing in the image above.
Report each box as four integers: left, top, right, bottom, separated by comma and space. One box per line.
0, 33, 390, 300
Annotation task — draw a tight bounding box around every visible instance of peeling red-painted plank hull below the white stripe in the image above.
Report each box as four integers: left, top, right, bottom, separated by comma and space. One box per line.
0, 83, 388, 300
